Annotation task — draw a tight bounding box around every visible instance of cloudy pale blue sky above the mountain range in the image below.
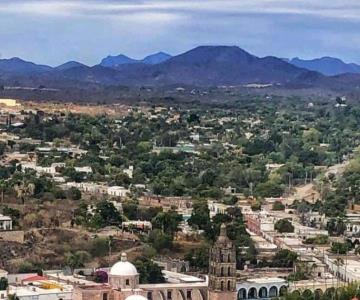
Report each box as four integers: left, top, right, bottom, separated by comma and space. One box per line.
0, 0, 360, 66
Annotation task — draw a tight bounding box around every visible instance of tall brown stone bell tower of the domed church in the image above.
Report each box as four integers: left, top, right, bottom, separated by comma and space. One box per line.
209, 224, 236, 300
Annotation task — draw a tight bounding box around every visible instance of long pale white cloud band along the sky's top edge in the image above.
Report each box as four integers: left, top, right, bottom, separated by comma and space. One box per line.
0, 0, 360, 20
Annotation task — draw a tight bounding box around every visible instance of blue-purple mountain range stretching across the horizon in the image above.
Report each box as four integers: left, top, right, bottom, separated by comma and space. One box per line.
0, 46, 360, 89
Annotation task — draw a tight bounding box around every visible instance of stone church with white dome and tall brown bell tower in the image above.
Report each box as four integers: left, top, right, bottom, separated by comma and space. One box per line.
73, 224, 237, 300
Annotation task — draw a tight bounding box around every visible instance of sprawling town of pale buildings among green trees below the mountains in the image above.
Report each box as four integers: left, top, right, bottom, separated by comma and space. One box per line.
0, 95, 360, 300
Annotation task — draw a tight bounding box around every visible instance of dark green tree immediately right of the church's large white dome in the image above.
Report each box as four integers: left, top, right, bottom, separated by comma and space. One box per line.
134, 257, 165, 284
